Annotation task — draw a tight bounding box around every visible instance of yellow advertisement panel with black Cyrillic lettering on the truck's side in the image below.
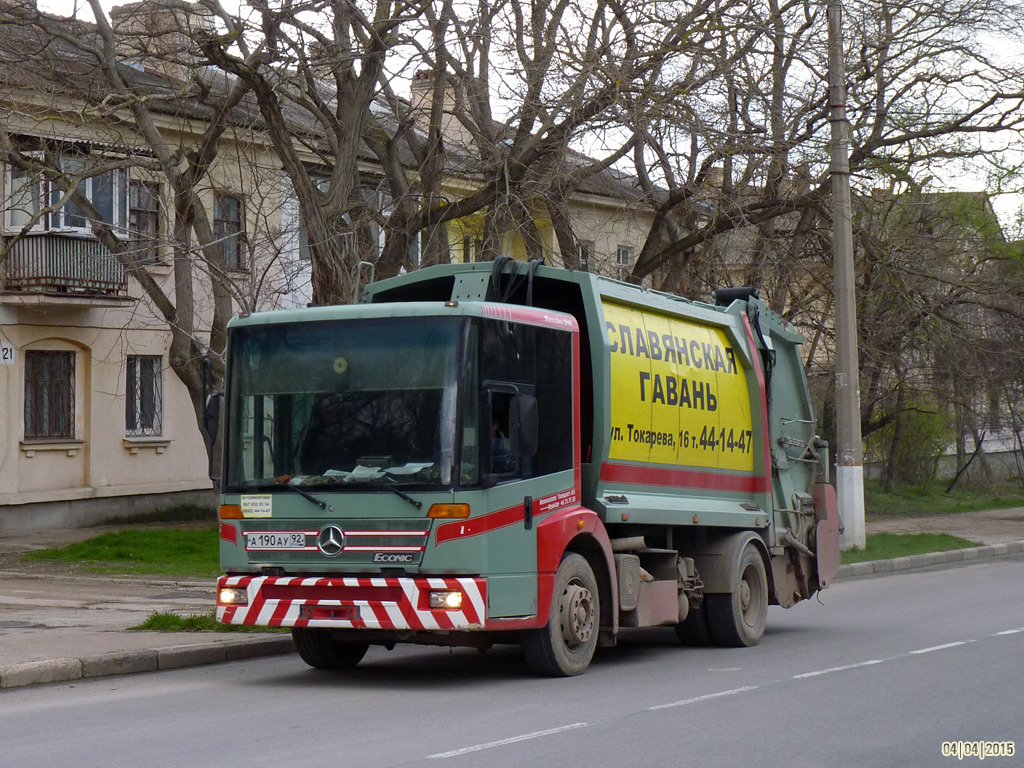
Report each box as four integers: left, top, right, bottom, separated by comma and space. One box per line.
603, 302, 754, 471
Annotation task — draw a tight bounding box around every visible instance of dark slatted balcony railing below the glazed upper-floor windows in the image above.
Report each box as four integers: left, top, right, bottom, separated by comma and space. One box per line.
0, 233, 128, 296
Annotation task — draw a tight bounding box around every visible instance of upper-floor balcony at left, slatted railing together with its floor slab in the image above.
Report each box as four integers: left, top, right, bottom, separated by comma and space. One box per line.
0, 232, 132, 307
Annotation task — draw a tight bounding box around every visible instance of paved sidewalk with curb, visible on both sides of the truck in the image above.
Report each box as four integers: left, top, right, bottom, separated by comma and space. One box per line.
0, 508, 1024, 688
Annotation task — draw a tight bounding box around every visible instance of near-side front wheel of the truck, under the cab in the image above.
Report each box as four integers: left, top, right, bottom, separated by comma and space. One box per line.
522, 552, 601, 677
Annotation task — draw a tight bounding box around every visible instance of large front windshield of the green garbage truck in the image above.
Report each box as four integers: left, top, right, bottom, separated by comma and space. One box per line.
226, 317, 461, 490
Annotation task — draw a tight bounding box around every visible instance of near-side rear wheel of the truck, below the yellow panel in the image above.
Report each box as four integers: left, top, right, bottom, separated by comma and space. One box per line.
705, 544, 768, 648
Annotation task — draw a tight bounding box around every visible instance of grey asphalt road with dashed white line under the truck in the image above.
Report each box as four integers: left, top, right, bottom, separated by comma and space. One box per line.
0, 557, 1024, 768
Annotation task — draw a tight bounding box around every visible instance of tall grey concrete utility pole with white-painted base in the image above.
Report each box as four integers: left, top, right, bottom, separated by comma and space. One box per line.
827, 0, 865, 549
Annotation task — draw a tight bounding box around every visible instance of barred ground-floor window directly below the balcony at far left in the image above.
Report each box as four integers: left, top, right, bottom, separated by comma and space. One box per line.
25, 350, 75, 439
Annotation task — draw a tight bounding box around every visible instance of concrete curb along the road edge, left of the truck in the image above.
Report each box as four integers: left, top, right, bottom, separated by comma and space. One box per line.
0, 636, 294, 688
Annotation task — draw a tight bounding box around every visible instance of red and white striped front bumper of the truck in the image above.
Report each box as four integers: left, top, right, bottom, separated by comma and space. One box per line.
217, 575, 487, 631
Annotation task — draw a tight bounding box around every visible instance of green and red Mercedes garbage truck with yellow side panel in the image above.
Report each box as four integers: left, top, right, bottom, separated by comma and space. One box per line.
210, 259, 839, 677
